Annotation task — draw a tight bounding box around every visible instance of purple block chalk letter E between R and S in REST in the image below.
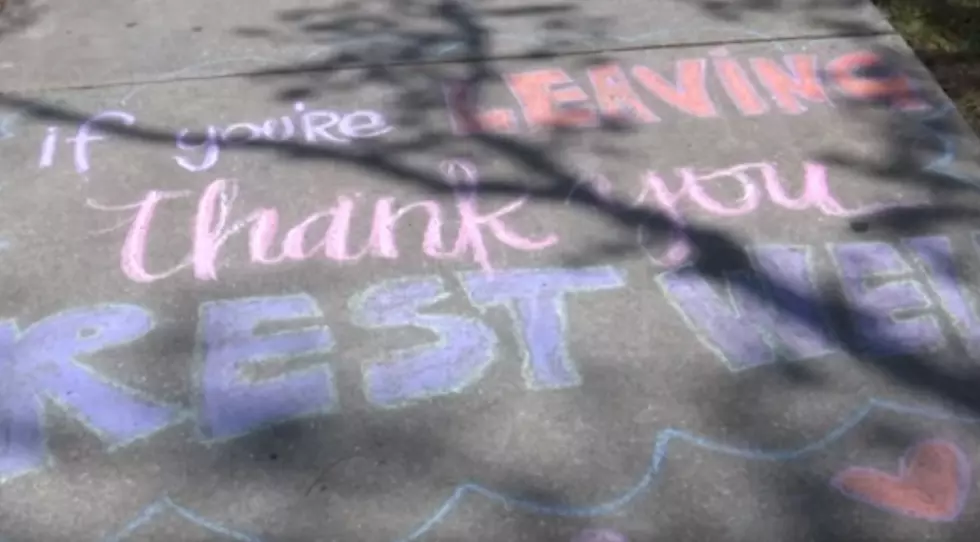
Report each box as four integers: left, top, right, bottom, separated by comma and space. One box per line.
199, 295, 337, 438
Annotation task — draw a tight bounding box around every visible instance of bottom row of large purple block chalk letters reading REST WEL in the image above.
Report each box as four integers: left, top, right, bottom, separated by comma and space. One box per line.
7, 227, 980, 479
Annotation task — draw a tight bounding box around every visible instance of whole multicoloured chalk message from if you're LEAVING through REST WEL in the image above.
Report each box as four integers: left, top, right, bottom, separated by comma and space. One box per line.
0, 45, 964, 510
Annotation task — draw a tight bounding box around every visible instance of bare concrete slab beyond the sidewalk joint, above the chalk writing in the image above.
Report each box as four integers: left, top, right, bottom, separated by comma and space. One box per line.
2, 0, 889, 90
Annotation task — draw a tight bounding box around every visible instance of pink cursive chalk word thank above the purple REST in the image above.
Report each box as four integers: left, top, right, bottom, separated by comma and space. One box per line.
90, 162, 558, 283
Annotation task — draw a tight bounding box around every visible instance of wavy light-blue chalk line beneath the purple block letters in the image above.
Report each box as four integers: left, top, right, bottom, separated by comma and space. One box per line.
104, 399, 980, 542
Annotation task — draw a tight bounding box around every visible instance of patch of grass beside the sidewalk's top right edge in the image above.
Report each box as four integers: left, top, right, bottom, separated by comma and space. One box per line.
873, 0, 980, 133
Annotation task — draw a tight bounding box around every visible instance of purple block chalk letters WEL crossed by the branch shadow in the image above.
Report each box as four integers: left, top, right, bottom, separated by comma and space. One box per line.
657, 236, 980, 371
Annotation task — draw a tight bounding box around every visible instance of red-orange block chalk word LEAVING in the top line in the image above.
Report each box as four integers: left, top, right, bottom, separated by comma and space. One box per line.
444, 48, 927, 134
